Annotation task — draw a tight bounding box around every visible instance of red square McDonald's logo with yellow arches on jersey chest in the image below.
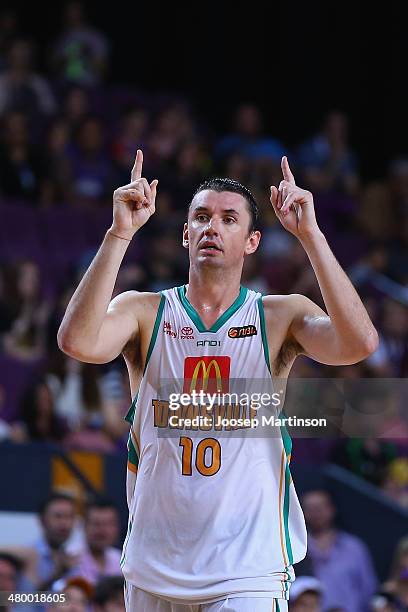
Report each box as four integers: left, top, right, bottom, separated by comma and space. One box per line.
183, 356, 231, 393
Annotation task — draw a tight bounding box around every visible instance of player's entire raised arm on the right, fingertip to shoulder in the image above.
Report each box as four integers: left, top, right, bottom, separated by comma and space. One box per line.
271, 157, 378, 365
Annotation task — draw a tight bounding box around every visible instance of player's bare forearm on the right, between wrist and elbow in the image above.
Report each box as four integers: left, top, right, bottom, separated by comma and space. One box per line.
299, 230, 378, 348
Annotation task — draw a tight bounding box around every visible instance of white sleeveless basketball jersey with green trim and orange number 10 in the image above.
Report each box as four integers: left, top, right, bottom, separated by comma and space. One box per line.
121, 286, 307, 603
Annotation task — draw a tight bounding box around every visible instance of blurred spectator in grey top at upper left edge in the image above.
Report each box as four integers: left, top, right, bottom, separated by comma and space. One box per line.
0, 39, 56, 119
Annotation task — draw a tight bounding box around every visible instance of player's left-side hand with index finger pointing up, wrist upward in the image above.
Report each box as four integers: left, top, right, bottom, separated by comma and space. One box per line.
110, 149, 158, 240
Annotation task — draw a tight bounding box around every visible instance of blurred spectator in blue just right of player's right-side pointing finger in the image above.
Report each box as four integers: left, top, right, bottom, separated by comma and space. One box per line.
297, 110, 359, 195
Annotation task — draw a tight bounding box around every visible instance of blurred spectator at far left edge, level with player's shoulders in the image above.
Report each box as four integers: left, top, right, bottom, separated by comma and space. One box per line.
2, 260, 50, 361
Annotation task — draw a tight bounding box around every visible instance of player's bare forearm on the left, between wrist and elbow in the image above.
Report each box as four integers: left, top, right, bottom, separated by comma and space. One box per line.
58, 230, 130, 348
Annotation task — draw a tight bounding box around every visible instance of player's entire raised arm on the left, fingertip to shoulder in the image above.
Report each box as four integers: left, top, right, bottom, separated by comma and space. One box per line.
57, 151, 157, 363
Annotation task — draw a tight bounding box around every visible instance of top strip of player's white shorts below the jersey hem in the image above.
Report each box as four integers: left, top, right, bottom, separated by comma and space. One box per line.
125, 581, 288, 612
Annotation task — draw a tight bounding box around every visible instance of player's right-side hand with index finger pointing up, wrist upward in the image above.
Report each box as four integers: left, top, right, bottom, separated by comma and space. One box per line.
271, 157, 320, 238
